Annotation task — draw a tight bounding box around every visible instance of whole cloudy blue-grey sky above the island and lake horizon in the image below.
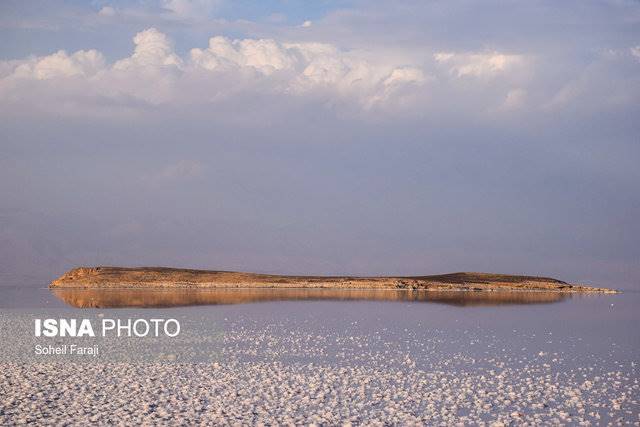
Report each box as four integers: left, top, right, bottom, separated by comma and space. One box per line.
0, 0, 640, 289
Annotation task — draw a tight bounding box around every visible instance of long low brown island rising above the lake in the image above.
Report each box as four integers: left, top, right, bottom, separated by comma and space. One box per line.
50, 267, 616, 293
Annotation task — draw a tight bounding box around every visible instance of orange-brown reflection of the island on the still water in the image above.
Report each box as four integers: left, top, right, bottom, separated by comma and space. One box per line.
52, 288, 571, 308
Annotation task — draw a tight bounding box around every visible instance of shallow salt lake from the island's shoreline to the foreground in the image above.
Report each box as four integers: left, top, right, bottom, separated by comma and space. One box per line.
0, 287, 640, 424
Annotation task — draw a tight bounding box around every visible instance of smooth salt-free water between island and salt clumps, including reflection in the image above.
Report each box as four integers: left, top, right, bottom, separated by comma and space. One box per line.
0, 286, 640, 361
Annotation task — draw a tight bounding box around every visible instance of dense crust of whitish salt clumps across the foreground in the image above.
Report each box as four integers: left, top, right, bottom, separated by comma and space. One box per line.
0, 348, 640, 425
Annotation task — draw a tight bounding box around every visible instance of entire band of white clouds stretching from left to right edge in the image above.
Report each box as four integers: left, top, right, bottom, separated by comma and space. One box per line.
0, 28, 637, 119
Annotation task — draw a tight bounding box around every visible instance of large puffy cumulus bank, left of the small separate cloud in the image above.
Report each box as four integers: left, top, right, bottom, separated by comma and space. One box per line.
0, 28, 426, 115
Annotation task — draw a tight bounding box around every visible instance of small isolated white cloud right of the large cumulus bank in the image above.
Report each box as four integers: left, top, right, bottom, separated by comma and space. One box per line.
434, 52, 524, 77
